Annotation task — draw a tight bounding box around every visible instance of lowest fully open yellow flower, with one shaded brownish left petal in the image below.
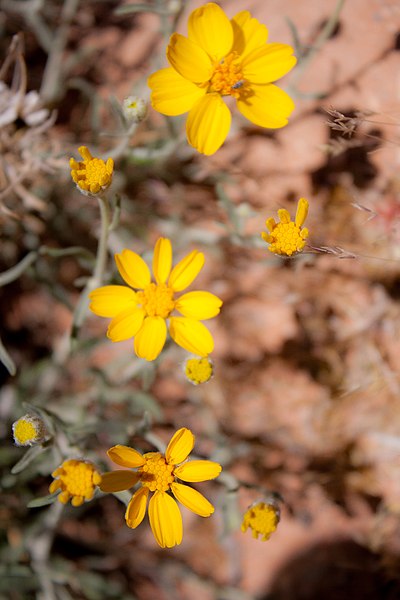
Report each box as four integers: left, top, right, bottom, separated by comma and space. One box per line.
100, 427, 221, 548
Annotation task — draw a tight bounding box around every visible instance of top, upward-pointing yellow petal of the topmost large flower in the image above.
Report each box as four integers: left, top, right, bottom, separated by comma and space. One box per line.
188, 2, 233, 60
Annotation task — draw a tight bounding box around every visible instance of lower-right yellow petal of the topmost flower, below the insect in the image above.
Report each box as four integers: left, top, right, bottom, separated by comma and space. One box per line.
237, 84, 294, 129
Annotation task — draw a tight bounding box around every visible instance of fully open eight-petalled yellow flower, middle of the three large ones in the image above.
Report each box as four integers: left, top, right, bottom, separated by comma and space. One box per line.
90, 238, 222, 360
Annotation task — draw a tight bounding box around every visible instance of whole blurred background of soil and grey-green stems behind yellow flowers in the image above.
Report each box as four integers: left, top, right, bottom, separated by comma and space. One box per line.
0, 0, 400, 600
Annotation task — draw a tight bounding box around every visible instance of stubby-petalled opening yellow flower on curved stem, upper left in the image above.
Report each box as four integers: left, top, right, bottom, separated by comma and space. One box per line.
69, 146, 114, 196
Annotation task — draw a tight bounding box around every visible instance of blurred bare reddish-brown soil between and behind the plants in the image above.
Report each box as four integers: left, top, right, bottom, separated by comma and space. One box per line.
0, 0, 400, 600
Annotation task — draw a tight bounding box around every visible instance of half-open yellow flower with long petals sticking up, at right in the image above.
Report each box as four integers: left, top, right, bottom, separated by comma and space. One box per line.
261, 198, 308, 256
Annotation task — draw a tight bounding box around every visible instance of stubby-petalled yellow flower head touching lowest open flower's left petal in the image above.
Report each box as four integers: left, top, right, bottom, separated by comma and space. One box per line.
49, 459, 101, 506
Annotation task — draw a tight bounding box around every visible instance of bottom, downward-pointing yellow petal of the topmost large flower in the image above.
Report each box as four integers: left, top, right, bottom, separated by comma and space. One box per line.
186, 93, 232, 156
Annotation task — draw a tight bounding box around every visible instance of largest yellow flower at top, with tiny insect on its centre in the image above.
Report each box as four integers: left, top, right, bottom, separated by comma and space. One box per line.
148, 2, 297, 155
